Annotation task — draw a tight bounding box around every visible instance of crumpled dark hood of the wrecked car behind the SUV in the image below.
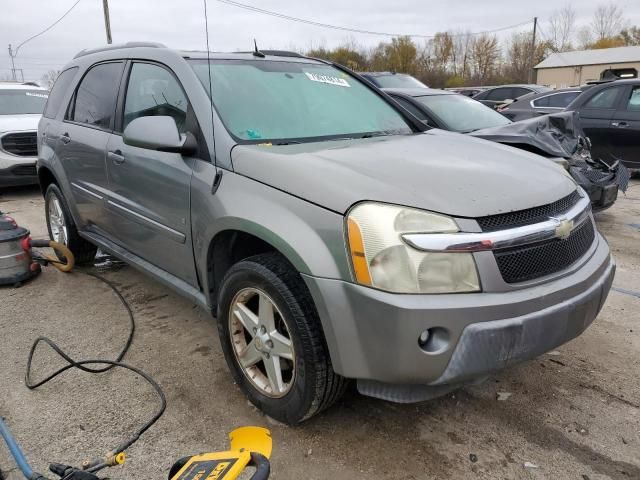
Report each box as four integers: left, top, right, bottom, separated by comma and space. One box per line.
470, 112, 585, 159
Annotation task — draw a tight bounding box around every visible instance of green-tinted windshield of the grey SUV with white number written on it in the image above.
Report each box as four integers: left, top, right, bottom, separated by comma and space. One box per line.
191, 60, 412, 143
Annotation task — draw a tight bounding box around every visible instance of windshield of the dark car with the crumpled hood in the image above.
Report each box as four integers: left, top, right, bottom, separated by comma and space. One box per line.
415, 94, 511, 132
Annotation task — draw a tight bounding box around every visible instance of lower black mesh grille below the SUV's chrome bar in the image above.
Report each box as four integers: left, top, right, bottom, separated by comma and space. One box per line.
494, 219, 595, 283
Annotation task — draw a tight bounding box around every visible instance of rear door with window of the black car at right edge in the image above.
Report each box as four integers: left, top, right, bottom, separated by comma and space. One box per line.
579, 85, 625, 162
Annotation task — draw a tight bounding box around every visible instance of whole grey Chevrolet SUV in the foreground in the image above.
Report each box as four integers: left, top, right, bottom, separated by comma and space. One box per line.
38, 44, 615, 424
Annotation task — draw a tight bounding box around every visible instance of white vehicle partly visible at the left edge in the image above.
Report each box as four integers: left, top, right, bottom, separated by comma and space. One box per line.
0, 82, 49, 188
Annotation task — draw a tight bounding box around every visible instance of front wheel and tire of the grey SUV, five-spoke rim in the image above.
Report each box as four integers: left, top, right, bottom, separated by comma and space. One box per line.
218, 253, 347, 425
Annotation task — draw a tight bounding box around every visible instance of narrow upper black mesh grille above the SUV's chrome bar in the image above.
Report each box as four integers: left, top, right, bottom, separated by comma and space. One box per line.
476, 190, 580, 232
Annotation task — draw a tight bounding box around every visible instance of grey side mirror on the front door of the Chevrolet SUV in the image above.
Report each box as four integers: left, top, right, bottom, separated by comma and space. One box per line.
122, 115, 198, 155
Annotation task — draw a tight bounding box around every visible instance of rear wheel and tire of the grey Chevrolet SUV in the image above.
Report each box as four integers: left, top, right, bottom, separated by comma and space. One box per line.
44, 183, 98, 264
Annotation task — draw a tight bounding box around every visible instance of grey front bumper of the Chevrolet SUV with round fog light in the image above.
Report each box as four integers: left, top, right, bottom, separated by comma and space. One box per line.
304, 235, 615, 401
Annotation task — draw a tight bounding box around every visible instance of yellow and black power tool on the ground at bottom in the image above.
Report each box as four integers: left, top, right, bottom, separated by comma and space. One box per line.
169, 427, 272, 480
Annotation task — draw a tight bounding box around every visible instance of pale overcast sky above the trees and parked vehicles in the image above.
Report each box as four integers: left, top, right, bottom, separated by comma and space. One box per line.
0, 0, 640, 80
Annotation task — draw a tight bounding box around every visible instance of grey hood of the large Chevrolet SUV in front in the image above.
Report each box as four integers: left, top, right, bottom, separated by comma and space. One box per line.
231, 129, 576, 217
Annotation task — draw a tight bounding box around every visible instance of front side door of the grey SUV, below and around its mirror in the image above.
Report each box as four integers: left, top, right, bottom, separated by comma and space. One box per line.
107, 61, 198, 286
